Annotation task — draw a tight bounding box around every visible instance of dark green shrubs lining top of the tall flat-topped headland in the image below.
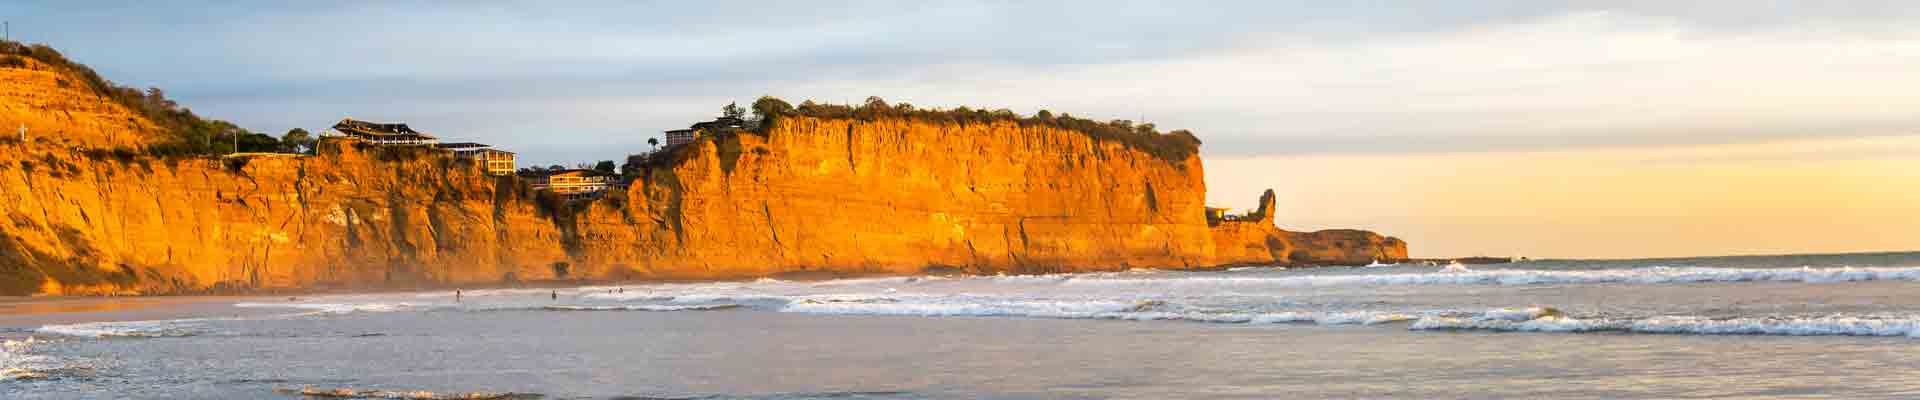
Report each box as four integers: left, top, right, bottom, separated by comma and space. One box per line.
744, 96, 1200, 163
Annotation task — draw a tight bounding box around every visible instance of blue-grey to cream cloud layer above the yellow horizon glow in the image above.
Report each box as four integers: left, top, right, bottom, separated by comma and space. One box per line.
15, 2, 1920, 162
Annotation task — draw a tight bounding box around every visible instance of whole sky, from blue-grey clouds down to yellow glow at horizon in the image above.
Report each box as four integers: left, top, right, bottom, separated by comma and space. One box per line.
0, 0, 1920, 258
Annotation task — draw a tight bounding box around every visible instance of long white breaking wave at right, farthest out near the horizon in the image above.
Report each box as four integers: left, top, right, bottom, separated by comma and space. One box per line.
1064, 265, 1920, 288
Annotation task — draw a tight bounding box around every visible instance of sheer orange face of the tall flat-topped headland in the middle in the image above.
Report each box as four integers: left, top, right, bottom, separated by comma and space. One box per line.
572, 117, 1213, 279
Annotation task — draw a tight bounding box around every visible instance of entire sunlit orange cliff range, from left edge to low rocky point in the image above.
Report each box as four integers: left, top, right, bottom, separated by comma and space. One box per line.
0, 47, 1405, 294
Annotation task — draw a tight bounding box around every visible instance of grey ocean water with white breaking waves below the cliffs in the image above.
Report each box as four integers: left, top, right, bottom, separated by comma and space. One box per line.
0, 252, 1920, 400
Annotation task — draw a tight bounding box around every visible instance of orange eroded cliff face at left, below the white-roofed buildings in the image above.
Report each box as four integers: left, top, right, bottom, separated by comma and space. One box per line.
0, 144, 564, 294
